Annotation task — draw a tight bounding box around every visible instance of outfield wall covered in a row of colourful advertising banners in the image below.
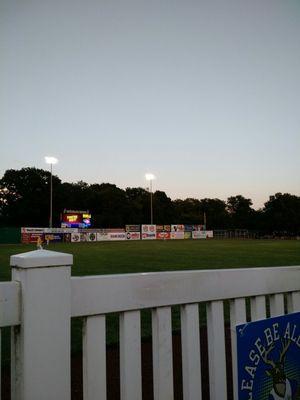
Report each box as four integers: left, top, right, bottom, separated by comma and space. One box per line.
21, 224, 213, 243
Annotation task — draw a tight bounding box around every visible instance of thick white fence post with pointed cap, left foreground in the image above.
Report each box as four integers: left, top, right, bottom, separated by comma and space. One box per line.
10, 250, 73, 400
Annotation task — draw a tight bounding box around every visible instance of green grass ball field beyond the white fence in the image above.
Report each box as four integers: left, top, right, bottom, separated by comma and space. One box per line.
0, 240, 300, 360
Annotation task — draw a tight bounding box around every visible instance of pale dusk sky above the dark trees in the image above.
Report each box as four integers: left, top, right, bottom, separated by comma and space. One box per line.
0, 0, 300, 208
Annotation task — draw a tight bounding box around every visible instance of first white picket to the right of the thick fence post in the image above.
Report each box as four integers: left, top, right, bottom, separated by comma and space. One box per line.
82, 315, 106, 400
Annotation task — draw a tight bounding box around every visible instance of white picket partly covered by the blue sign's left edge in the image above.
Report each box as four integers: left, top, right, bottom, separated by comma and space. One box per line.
230, 298, 246, 400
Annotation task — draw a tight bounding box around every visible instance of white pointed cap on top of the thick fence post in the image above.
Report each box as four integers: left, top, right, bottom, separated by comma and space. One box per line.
10, 250, 73, 268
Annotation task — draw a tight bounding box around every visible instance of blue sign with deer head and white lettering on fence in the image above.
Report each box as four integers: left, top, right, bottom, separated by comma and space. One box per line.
236, 312, 300, 400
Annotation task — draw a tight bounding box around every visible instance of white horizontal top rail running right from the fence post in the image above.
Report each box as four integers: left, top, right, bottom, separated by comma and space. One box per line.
71, 266, 300, 317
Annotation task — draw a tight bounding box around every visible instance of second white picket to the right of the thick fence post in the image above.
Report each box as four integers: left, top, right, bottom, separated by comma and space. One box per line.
120, 311, 142, 400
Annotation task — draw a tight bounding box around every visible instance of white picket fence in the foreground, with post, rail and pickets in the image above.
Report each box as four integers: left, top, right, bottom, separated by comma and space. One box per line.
0, 250, 300, 400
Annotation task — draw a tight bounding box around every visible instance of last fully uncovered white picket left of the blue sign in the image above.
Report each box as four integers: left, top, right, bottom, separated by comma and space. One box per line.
207, 301, 227, 400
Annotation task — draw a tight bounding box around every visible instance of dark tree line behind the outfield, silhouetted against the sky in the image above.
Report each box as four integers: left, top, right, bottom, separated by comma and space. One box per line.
0, 167, 300, 234
